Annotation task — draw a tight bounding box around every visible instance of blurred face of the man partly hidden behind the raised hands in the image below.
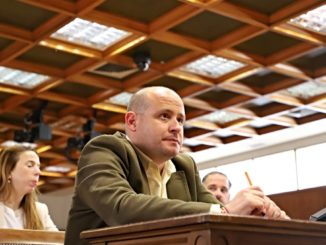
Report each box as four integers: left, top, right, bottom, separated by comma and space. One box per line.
202, 171, 231, 204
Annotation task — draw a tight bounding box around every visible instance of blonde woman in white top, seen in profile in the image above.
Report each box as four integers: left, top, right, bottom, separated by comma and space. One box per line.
0, 146, 58, 231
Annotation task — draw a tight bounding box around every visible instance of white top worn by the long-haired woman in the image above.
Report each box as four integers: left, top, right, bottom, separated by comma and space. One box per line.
0, 202, 58, 231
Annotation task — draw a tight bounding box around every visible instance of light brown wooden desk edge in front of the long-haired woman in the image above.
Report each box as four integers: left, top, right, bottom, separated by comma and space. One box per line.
0, 229, 65, 245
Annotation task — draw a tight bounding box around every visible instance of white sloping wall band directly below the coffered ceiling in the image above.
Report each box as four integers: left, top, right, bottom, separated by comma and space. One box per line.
190, 119, 326, 170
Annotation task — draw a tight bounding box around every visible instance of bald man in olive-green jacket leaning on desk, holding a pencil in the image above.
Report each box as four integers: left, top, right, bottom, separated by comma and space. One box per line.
65, 87, 285, 245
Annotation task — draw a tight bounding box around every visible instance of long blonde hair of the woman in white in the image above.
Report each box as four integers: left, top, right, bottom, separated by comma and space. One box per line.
0, 146, 44, 230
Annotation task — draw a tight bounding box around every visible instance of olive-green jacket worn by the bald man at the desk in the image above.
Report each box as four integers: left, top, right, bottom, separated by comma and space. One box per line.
65, 133, 218, 245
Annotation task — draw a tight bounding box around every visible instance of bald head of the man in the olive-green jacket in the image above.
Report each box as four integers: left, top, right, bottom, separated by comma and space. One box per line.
125, 86, 185, 166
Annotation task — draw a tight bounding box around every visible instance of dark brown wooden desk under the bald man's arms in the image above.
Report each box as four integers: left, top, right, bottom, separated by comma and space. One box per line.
81, 214, 326, 245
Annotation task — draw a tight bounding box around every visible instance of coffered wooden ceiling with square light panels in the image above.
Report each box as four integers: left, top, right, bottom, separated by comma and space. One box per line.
0, 0, 326, 192
